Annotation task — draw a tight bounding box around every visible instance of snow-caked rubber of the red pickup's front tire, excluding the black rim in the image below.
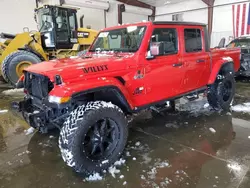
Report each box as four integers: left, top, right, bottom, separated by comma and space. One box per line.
59, 101, 128, 175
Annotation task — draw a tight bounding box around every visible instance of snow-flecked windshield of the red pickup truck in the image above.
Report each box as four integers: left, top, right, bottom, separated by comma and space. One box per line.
90, 26, 146, 52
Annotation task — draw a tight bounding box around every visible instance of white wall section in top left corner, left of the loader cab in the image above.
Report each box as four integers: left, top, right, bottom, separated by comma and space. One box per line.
0, 0, 37, 34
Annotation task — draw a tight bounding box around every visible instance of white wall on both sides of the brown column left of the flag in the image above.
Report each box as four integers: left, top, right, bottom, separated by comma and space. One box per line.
156, 0, 249, 47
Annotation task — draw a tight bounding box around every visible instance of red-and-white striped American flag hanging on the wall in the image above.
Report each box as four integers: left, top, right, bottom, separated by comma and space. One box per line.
232, 3, 250, 37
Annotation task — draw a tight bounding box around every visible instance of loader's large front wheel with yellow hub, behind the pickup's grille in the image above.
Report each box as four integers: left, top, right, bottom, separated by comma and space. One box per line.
2, 50, 41, 86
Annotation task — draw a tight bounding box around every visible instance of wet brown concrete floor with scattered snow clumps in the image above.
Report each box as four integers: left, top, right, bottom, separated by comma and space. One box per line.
0, 83, 250, 188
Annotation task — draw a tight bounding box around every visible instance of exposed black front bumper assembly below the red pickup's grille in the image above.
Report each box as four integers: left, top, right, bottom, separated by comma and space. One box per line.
14, 97, 70, 133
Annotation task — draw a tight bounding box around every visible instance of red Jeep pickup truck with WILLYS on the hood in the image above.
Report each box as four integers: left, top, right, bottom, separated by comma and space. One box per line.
15, 22, 240, 174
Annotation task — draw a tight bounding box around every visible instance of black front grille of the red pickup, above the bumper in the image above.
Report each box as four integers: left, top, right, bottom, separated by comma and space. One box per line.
24, 72, 54, 99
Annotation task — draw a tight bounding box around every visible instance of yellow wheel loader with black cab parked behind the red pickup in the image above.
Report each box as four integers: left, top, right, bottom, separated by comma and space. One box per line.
0, 5, 98, 85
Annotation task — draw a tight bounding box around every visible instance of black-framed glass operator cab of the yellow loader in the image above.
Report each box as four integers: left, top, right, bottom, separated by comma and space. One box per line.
36, 5, 77, 50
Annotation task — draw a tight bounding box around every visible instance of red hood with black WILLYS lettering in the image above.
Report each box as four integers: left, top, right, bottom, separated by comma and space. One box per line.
25, 54, 134, 82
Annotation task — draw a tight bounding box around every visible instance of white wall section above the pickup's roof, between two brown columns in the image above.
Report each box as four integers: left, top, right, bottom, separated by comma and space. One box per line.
155, 0, 208, 24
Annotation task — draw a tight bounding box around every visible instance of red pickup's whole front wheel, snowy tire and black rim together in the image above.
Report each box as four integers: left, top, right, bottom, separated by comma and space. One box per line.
59, 101, 128, 175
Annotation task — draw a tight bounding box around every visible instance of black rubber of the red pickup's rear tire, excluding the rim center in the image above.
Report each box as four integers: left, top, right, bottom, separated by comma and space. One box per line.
207, 74, 235, 111
